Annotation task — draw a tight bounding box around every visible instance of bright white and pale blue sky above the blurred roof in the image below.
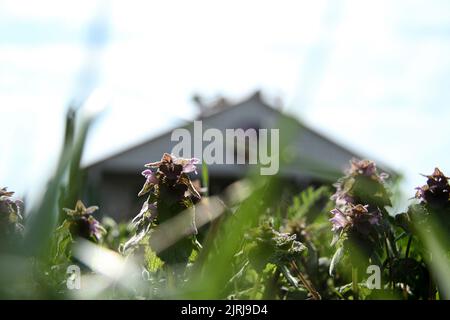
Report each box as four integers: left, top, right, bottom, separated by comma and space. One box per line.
0, 0, 450, 210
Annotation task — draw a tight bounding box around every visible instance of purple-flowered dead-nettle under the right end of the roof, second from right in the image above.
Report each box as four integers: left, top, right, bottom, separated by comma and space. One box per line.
329, 159, 395, 295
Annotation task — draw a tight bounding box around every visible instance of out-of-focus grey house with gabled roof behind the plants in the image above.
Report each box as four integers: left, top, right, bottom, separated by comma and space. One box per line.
83, 92, 390, 220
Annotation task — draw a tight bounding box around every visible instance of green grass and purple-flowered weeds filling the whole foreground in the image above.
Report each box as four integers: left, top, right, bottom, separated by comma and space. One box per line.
0, 110, 450, 300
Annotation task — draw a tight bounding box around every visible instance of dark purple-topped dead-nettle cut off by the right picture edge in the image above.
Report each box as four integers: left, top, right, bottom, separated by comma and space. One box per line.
395, 168, 450, 299
